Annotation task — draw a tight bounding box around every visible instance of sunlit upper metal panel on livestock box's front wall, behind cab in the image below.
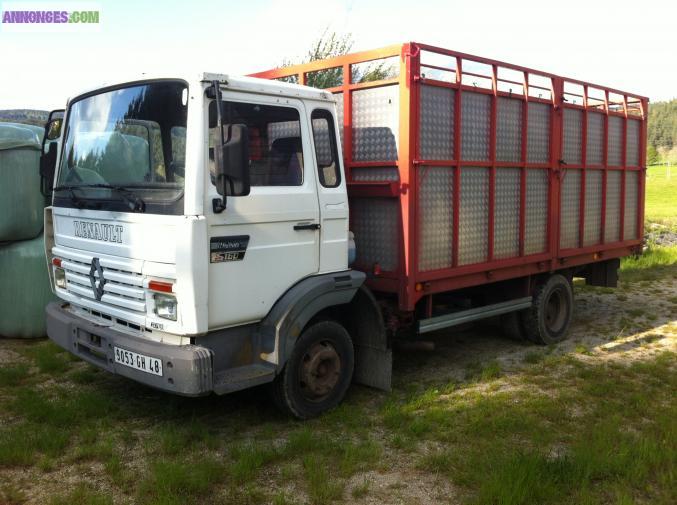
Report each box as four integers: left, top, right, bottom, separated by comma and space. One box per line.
352, 85, 400, 161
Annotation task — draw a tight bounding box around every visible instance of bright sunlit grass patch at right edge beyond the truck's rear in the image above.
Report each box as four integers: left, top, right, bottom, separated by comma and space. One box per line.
644, 166, 677, 225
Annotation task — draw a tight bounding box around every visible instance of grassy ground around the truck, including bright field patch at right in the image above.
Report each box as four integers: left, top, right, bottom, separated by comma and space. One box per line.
0, 167, 677, 505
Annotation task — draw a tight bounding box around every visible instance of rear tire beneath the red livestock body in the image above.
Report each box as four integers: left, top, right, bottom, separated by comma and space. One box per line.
520, 274, 574, 345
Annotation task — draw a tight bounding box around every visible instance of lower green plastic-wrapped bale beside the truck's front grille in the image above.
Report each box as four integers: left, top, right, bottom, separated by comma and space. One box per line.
0, 235, 56, 338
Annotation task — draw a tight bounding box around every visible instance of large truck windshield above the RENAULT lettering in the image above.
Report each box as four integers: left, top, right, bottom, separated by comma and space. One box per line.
54, 81, 188, 214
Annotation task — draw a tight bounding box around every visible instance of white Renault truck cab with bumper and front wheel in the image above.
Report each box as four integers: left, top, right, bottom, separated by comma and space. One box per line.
41, 74, 391, 418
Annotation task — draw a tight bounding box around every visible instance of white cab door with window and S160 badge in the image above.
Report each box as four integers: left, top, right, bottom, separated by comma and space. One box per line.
205, 91, 320, 329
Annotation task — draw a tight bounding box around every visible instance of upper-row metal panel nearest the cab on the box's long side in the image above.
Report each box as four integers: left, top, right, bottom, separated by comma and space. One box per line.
419, 85, 456, 160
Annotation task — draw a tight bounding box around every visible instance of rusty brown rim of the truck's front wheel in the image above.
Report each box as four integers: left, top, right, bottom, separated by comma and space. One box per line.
300, 341, 341, 402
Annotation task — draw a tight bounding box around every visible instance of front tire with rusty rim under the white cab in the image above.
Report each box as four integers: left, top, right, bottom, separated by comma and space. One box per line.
272, 321, 355, 419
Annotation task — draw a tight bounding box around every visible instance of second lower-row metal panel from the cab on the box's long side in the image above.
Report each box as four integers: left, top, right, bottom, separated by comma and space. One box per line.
458, 167, 489, 265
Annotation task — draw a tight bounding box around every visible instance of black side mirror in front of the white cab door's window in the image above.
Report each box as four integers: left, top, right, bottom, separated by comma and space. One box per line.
214, 124, 251, 212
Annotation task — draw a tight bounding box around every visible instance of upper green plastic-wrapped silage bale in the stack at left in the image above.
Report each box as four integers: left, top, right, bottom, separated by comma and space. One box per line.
0, 123, 45, 243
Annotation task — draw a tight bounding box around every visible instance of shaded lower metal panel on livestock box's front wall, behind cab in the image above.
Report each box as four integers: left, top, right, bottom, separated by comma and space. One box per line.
350, 198, 399, 271
